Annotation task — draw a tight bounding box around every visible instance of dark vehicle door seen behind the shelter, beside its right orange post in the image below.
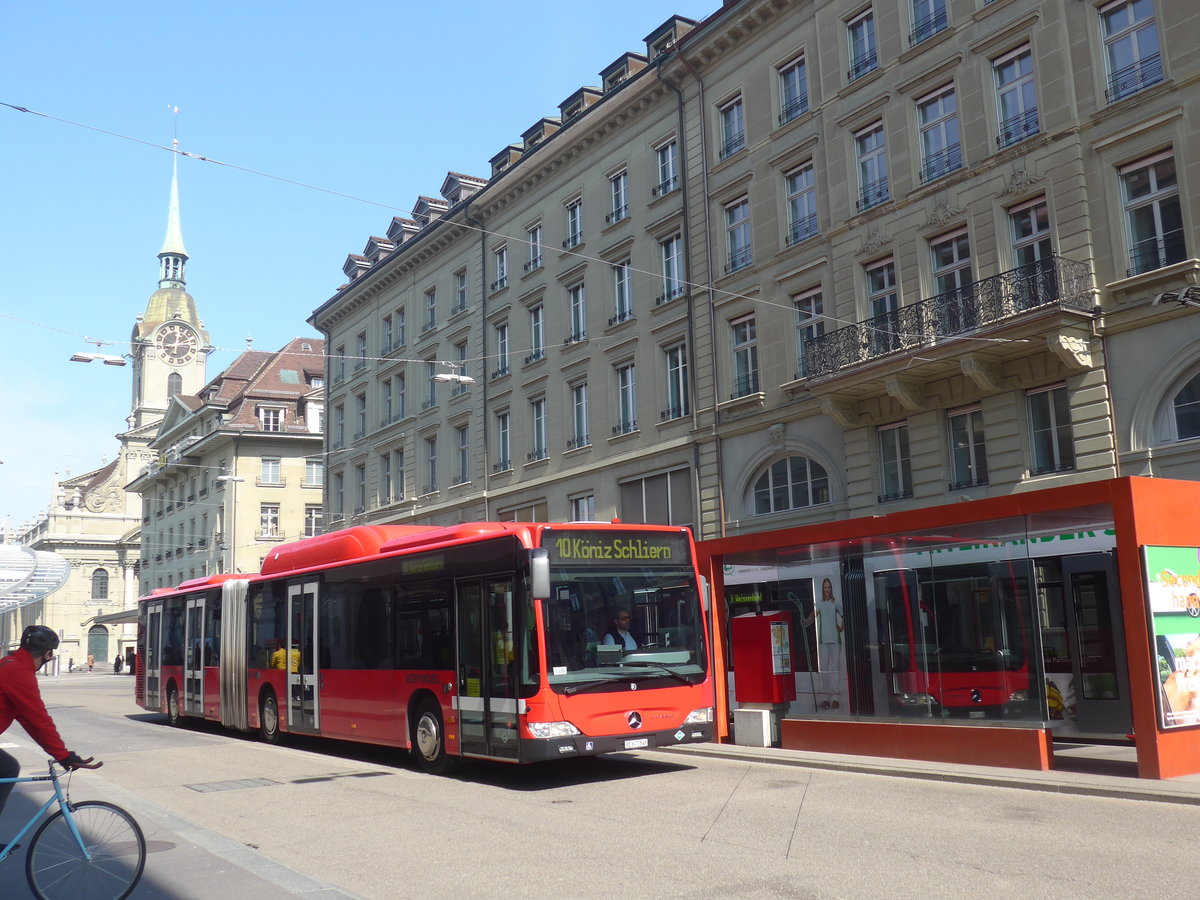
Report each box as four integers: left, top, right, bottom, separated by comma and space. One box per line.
1062, 553, 1133, 736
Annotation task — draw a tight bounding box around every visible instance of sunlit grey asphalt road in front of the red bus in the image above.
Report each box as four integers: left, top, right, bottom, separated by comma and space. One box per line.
0, 674, 1200, 900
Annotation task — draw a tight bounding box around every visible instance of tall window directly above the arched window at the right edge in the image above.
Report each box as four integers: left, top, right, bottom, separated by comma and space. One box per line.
1121, 152, 1187, 276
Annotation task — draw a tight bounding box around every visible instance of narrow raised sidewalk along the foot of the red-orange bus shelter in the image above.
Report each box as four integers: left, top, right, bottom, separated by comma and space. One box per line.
661, 743, 1200, 805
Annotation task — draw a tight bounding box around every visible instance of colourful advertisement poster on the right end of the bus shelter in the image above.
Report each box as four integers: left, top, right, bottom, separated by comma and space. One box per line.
1142, 547, 1200, 728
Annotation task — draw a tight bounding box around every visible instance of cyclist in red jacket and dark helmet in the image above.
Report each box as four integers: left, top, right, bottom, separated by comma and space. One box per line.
0, 625, 101, 811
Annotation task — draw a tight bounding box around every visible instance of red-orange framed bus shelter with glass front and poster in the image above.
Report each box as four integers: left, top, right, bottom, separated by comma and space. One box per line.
698, 478, 1200, 779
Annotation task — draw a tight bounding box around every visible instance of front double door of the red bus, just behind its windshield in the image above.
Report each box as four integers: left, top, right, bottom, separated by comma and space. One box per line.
456, 577, 521, 760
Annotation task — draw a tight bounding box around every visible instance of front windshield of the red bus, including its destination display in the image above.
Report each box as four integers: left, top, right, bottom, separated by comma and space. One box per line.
544, 532, 707, 694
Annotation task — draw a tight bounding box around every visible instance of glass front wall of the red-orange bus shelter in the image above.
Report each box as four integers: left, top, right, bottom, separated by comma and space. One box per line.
722, 510, 1129, 734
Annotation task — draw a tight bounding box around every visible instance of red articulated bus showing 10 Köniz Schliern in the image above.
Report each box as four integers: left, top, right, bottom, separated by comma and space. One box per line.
136, 522, 714, 773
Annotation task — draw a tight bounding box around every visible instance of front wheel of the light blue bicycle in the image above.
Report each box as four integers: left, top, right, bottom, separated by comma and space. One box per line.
25, 800, 146, 900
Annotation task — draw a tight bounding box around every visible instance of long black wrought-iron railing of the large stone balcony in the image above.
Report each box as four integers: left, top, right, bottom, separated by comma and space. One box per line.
804, 257, 1093, 378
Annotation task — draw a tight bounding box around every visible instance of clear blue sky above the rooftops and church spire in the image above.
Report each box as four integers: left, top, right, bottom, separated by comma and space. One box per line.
0, 0, 705, 527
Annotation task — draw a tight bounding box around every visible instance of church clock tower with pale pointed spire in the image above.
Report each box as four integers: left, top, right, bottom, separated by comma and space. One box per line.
128, 156, 212, 438
